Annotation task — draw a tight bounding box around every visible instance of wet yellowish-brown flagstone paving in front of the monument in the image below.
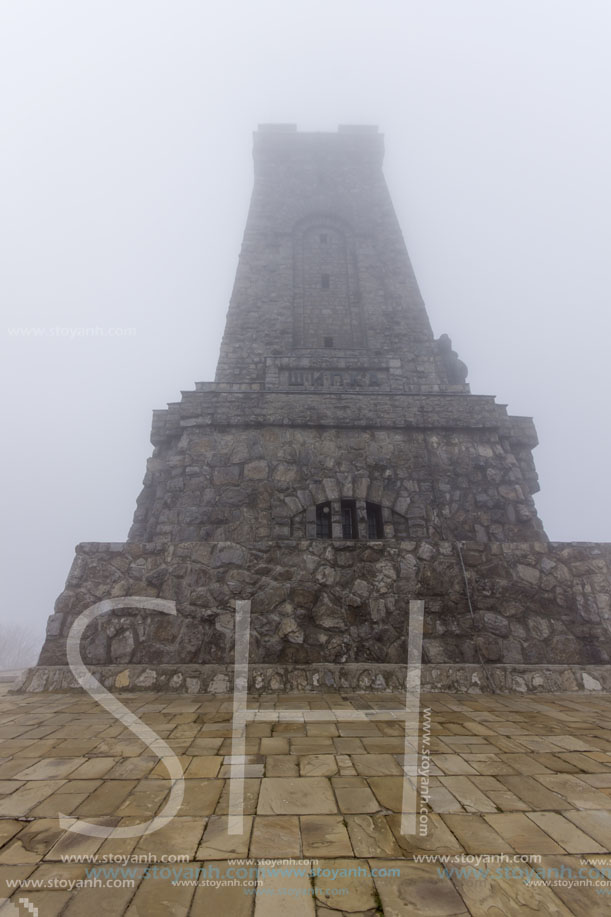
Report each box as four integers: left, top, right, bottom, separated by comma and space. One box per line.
0, 685, 611, 917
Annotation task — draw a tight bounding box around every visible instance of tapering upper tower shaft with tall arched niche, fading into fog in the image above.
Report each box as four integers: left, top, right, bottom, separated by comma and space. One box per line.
216, 125, 448, 392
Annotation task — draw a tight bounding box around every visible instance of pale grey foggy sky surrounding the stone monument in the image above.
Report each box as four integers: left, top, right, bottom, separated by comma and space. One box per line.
0, 0, 611, 644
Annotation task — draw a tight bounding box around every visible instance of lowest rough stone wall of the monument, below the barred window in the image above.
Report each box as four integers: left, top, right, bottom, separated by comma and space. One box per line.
39, 540, 611, 672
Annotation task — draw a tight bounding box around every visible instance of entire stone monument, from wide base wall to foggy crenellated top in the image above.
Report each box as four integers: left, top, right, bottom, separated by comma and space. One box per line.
25, 125, 611, 691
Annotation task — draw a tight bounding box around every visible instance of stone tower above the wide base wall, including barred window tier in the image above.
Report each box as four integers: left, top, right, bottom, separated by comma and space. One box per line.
129, 125, 544, 543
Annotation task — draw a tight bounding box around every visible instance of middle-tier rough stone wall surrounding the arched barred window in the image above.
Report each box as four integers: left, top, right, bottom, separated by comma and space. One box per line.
130, 425, 545, 543
